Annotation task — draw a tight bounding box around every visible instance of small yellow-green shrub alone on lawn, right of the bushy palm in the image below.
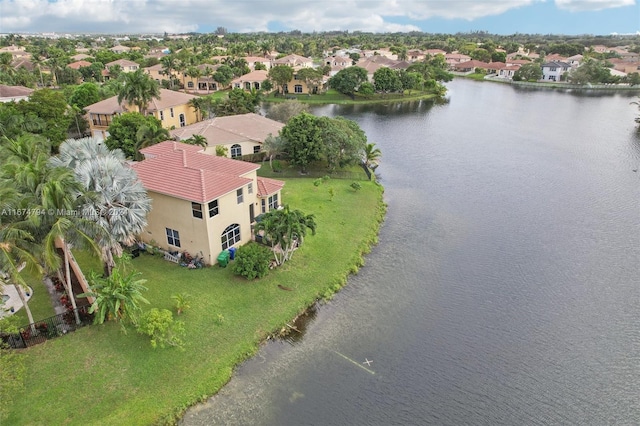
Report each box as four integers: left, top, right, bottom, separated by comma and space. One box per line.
138, 308, 184, 349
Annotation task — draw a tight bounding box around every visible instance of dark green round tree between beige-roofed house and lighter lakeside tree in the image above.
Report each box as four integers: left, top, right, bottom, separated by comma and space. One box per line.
280, 112, 323, 173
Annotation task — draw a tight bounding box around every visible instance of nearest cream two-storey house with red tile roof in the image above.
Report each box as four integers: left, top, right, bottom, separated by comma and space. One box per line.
131, 141, 284, 265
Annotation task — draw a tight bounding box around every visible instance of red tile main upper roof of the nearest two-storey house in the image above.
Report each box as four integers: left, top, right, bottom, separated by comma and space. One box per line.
131, 141, 260, 203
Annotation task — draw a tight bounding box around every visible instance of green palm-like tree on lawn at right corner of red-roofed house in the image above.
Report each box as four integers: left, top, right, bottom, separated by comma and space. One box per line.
255, 205, 316, 266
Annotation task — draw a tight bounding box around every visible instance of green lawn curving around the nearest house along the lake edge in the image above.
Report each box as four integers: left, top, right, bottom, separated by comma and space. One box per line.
7, 179, 384, 425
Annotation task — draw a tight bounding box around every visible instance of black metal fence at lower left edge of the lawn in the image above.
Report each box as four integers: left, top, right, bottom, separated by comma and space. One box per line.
0, 306, 93, 349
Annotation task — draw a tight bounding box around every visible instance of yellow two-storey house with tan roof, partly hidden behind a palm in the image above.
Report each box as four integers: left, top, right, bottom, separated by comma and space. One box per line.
85, 89, 198, 139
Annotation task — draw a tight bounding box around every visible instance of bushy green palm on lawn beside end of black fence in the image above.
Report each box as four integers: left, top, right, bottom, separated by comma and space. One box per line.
78, 267, 149, 324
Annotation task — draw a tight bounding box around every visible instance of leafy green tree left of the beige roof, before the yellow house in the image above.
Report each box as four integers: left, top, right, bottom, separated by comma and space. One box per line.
104, 112, 161, 158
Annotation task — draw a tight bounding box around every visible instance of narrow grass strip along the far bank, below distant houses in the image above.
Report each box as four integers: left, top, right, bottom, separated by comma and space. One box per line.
264, 89, 436, 105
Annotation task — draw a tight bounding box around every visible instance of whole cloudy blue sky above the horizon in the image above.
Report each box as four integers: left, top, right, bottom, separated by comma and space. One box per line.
0, 0, 640, 35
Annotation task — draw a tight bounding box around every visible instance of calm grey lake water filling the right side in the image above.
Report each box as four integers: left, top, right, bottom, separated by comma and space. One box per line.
183, 80, 640, 425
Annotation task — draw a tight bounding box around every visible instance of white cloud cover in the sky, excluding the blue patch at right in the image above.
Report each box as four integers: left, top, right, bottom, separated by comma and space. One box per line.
0, 0, 635, 33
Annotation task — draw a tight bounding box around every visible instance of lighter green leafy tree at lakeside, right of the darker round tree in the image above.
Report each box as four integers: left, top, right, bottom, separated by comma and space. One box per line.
317, 117, 367, 169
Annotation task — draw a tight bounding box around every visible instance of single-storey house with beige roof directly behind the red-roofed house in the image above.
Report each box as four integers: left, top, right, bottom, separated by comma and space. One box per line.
170, 113, 284, 158
